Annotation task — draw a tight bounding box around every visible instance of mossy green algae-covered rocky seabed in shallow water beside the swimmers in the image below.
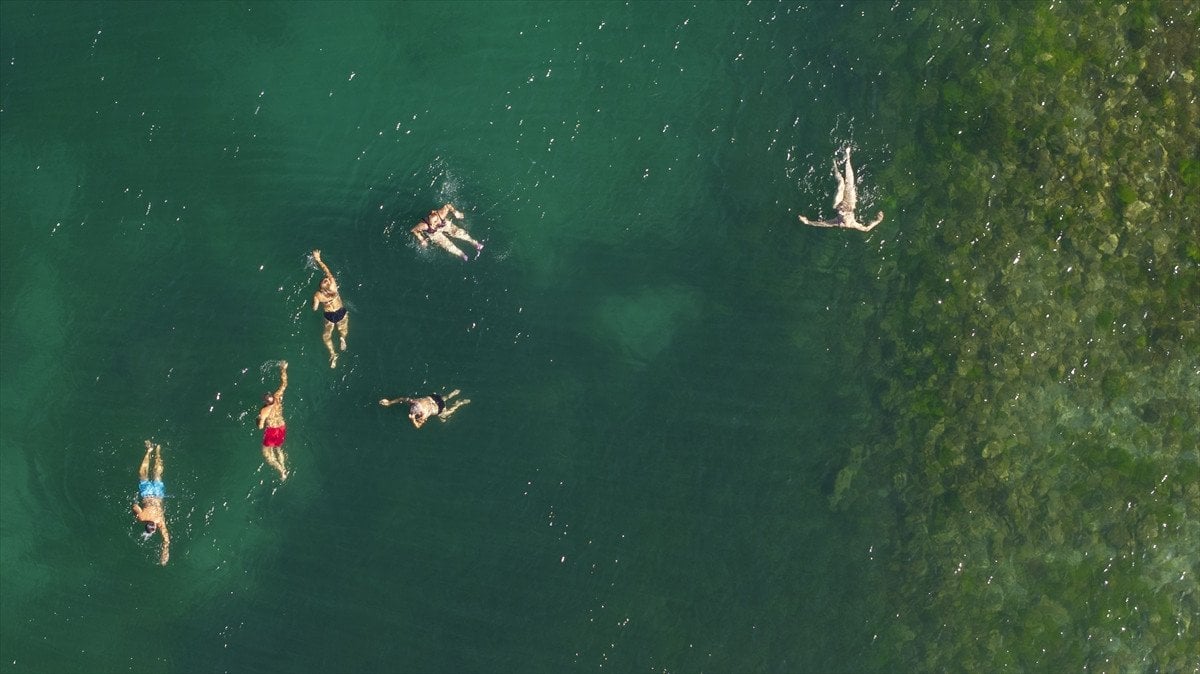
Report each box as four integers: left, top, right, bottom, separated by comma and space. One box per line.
825, 1, 1200, 672
